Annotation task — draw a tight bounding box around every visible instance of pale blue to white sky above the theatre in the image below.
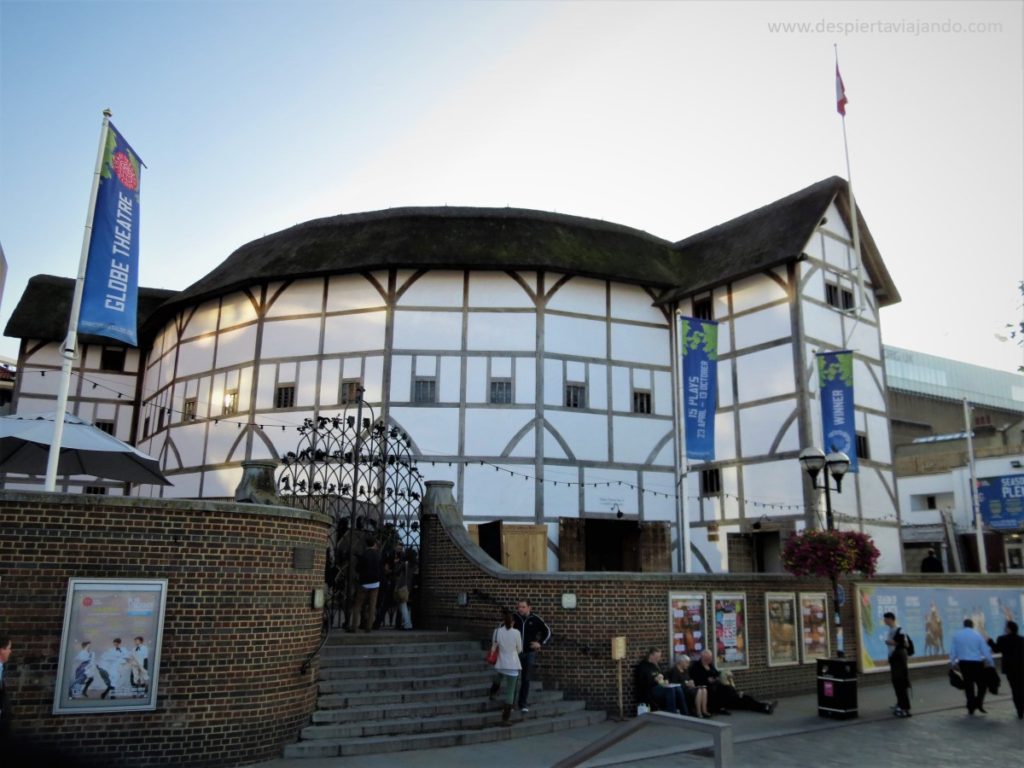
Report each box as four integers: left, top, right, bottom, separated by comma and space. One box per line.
0, 0, 1024, 371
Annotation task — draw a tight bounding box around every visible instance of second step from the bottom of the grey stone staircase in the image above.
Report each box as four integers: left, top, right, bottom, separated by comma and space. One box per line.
301, 699, 585, 741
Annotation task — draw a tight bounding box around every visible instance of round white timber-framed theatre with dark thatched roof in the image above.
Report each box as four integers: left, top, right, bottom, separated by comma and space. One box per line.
6, 177, 902, 572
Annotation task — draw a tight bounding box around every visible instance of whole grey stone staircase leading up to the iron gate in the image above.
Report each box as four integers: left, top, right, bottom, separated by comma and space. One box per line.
285, 631, 605, 758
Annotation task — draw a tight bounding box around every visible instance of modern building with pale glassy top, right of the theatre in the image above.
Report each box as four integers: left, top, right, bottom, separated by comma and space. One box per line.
885, 346, 1024, 572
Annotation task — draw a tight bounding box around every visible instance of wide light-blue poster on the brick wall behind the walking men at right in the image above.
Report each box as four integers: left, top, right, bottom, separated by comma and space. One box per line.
857, 584, 1024, 673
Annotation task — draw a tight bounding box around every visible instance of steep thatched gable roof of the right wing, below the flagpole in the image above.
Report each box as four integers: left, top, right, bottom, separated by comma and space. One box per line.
659, 176, 900, 306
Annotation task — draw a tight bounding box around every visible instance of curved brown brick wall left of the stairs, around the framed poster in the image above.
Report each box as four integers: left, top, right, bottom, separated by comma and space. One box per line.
0, 492, 329, 767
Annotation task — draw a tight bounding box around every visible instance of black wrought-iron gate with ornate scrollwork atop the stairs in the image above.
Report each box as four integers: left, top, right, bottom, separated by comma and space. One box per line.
276, 388, 423, 651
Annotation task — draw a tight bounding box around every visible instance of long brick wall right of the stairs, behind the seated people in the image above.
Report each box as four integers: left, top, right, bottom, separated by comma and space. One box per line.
418, 482, 1019, 714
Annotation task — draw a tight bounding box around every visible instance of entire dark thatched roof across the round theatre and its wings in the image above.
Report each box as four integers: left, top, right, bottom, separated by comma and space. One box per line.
5, 176, 899, 339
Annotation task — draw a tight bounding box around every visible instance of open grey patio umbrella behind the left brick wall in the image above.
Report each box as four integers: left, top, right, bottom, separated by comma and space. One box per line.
0, 414, 171, 485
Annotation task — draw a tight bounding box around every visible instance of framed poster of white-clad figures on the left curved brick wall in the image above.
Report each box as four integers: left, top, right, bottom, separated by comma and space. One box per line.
53, 578, 167, 715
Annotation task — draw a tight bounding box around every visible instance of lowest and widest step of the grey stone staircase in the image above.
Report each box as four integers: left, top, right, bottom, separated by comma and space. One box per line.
285, 709, 605, 759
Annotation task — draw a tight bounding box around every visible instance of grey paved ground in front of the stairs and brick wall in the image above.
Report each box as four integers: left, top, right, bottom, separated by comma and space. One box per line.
251, 677, 1024, 768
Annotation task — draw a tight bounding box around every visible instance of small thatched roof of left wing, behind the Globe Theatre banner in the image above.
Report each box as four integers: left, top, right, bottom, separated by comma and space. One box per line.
4, 274, 177, 344
